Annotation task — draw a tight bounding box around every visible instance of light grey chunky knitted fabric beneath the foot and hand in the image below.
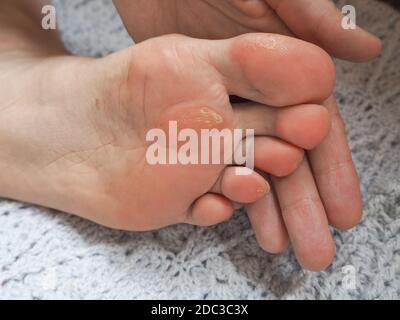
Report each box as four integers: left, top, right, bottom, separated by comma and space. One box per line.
0, 0, 400, 299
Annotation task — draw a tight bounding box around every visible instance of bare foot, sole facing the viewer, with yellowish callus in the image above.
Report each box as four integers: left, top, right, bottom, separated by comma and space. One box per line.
0, 18, 334, 230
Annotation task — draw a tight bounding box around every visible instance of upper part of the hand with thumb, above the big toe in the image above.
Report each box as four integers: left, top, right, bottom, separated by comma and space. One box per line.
114, 0, 381, 61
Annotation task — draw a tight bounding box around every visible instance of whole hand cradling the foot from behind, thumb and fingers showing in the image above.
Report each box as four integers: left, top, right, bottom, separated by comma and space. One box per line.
114, 0, 381, 270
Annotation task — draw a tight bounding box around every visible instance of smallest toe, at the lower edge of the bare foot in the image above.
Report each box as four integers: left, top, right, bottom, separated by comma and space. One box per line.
185, 193, 234, 227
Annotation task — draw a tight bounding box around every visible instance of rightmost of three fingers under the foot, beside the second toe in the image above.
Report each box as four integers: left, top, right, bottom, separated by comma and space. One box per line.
309, 97, 362, 229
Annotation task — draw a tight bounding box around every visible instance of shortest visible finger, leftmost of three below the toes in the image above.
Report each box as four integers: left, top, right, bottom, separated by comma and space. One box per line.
246, 176, 289, 254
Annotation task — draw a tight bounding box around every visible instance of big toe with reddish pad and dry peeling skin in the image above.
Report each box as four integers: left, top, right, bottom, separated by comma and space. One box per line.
207, 34, 335, 106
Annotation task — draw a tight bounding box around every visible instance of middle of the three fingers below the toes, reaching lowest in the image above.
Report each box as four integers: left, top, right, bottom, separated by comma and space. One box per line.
272, 159, 335, 271
